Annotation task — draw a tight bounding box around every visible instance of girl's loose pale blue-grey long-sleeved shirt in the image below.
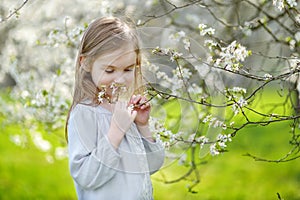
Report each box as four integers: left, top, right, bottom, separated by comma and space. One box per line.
68, 104, 164, 200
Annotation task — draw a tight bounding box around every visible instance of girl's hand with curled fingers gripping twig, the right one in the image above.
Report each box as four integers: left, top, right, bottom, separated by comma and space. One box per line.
129, 95, 151, 126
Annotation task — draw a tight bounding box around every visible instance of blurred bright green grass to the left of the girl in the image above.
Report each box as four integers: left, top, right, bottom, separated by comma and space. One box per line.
0, 125, 76, 200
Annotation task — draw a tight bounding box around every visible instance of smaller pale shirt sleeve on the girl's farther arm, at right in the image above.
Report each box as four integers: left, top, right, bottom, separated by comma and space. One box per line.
142, 138, 165, 174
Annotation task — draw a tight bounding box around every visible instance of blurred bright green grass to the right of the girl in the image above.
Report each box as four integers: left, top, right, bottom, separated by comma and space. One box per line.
154, 120, 300, 200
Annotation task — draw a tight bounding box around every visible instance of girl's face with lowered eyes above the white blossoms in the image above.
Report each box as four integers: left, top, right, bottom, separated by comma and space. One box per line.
91, 45, 137, 99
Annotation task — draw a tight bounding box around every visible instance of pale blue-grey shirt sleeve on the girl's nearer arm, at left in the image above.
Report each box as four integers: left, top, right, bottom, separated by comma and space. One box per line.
68, 104, 120, 189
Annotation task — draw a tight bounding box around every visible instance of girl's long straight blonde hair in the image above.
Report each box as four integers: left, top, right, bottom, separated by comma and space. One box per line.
65, 17, 143, 139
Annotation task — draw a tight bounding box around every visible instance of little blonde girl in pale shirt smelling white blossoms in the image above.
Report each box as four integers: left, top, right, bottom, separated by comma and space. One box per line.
66, 17, 164, 200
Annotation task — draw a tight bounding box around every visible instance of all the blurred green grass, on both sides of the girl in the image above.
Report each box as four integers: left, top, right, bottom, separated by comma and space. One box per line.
0, 119, 300, 200
